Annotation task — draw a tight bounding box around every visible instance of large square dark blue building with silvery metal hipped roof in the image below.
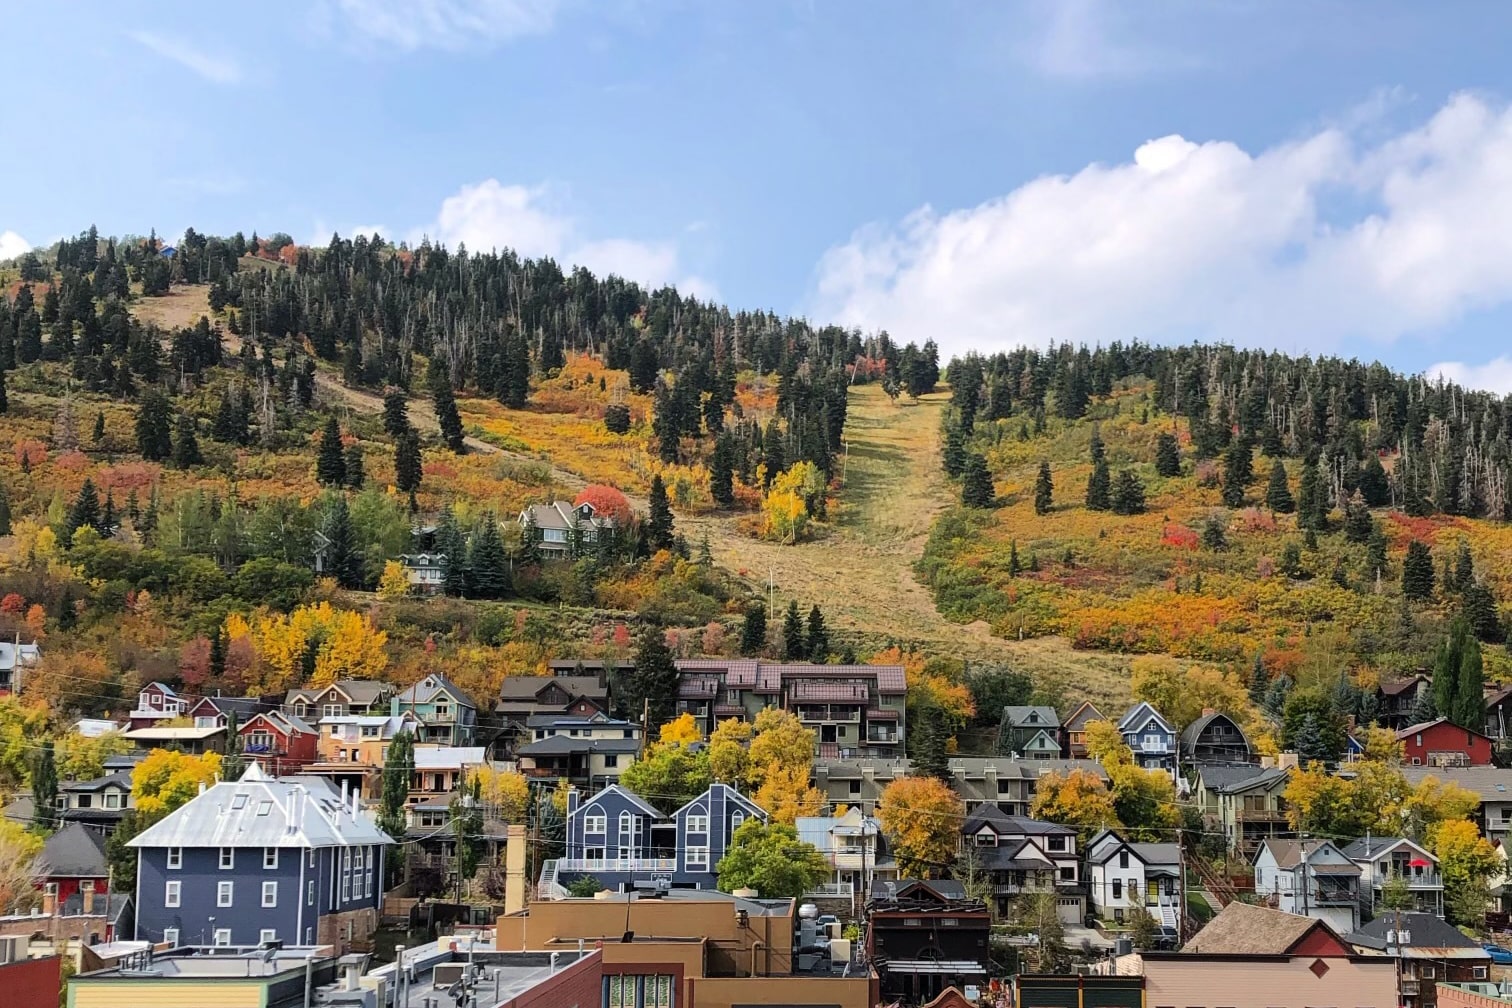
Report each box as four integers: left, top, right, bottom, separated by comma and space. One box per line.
129, 763, 393, 952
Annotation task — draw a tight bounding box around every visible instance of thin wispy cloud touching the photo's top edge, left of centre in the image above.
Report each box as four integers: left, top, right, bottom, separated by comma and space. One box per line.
333, 0, 559, 50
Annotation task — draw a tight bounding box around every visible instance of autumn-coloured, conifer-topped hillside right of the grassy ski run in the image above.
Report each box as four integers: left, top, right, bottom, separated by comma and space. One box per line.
919, 343, 1512, 764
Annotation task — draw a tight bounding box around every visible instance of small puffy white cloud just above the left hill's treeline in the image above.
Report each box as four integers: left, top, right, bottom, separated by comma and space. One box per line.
411, 178, 715, 298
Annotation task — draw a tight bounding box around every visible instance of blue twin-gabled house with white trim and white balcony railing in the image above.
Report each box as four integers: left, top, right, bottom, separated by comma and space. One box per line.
541, 784, 768, 890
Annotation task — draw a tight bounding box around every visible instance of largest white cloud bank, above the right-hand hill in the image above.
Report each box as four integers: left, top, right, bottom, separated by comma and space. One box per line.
815, 95, 1512, 362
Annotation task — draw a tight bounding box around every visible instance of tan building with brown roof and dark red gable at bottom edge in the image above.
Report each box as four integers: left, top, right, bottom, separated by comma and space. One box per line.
1096, 902, 1397, 1008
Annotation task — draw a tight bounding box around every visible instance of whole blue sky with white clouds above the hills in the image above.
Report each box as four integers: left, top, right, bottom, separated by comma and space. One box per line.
0, 0, 1512, 393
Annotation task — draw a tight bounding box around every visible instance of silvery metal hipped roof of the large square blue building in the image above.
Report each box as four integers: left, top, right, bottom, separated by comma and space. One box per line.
127, 763, 393, 848
